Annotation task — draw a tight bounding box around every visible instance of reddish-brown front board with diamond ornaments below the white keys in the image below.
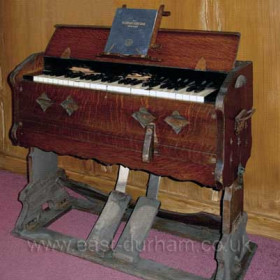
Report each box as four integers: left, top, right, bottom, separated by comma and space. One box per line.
16, 81, 217, 154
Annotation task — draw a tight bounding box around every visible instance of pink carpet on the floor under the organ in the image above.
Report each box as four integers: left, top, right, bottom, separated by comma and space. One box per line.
0, 168, 280, 280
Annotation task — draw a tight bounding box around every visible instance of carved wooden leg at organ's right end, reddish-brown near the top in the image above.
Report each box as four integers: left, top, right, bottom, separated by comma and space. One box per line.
215, 170, 256, 280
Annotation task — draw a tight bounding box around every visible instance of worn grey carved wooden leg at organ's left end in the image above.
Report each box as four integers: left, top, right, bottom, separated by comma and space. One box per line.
14, 148, 71, 234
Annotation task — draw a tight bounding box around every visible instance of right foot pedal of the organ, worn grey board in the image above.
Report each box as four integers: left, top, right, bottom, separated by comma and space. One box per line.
113, 197, 160, 262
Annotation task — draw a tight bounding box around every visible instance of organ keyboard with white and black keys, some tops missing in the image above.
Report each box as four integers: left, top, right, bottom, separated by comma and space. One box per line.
24, 62, 220, 103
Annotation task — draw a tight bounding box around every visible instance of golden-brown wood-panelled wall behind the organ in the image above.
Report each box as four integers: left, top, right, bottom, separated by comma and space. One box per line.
0, 0, 280, 238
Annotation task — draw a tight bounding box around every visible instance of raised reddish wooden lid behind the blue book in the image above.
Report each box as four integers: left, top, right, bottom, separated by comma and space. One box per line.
45, 25, 240, 72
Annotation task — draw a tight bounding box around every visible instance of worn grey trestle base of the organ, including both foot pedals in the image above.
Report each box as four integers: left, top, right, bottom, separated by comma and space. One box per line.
13, 149, 257, 280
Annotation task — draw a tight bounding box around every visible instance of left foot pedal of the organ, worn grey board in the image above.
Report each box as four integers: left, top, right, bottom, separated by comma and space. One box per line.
87, 191, 131, 254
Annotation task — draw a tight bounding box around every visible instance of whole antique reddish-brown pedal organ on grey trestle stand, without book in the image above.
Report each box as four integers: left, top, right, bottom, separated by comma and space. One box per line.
10, 6, 256, 280
